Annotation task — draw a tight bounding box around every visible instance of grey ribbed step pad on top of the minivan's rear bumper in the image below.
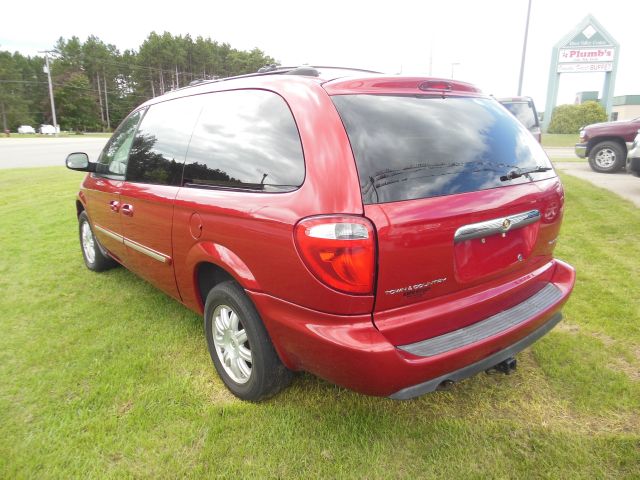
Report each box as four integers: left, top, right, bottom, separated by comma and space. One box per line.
397, 283, 562, 357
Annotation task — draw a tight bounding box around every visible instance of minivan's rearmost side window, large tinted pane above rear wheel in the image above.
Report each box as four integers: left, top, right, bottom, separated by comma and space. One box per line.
184, 90, 305, 192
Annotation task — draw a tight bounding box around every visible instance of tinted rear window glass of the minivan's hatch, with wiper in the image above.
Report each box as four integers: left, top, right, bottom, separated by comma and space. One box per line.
332, 95, 555, 204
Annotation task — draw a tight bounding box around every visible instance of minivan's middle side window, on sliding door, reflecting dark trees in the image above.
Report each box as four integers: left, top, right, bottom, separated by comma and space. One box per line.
127, 96, 202, 186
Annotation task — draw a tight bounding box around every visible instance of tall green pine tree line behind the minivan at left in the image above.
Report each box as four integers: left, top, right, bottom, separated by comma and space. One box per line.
0, 32, 276, 131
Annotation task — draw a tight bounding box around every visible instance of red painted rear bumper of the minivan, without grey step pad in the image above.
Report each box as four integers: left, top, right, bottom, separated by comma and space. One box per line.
249, 260, 575, 399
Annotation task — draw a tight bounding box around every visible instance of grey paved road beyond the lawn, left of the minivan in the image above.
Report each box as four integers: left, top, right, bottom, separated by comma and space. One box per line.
0, 137, 108, 168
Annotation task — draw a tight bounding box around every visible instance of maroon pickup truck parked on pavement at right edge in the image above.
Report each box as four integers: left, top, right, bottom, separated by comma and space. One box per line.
575, 117, 640, 173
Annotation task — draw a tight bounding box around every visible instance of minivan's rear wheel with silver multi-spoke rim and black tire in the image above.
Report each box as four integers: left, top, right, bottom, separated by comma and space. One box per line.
204, 281, 293, 402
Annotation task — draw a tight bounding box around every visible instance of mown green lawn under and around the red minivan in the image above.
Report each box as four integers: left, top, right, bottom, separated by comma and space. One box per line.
0, 168, 640, 479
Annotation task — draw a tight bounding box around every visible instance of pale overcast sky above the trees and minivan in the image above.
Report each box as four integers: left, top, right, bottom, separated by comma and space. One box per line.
0, 0, 640, 110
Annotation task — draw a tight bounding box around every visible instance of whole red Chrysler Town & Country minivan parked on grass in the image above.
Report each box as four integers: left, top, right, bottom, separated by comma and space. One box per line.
67, 67, 575, 401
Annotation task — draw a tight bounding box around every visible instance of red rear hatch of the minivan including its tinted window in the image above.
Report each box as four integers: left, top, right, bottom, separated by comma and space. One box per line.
325, 79, 563, 344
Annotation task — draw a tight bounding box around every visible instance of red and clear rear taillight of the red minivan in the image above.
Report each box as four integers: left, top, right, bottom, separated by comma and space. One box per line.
295, 216, 376, 295
